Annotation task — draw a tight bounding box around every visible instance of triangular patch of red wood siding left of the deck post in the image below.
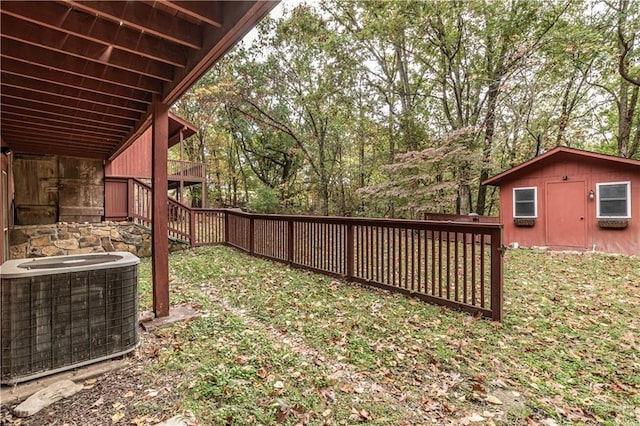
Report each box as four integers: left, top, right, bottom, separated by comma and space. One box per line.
105, 127, 151, 179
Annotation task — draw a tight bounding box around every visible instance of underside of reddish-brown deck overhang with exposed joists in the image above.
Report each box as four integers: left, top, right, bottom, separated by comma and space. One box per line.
0, 0, 277, 159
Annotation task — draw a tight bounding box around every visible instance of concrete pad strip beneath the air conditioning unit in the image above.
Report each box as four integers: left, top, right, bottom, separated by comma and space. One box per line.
0, 359, 128, 405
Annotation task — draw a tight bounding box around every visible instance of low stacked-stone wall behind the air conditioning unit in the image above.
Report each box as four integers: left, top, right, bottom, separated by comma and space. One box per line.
9, 222, 189, 259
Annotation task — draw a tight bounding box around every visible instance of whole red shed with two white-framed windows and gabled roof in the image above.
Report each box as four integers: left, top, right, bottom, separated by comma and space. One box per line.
483, 147, 640, 255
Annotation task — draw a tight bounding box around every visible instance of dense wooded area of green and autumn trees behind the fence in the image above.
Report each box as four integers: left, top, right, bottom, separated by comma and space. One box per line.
175, 0, 640, 218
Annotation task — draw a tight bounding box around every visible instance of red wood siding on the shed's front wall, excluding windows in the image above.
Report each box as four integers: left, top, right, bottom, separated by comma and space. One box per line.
500, 158, 640, 255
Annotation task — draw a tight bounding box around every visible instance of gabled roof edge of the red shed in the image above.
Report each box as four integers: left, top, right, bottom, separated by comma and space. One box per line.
482, 146, 640, 186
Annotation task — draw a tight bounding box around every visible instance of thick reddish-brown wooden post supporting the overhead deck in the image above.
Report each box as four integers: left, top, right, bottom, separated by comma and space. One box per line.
151, 99, 169, 317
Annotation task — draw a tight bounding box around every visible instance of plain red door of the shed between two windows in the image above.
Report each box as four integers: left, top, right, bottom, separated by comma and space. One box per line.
545, 181, 587, 248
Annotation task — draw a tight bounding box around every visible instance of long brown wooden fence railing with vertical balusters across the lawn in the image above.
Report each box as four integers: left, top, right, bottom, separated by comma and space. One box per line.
106, 179, 503, 321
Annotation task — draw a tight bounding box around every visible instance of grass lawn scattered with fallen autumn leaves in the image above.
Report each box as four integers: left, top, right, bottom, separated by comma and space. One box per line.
141, 247, 640, 425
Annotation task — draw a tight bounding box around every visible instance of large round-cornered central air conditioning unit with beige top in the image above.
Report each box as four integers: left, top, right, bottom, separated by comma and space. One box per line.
0, 252, 140, 384
